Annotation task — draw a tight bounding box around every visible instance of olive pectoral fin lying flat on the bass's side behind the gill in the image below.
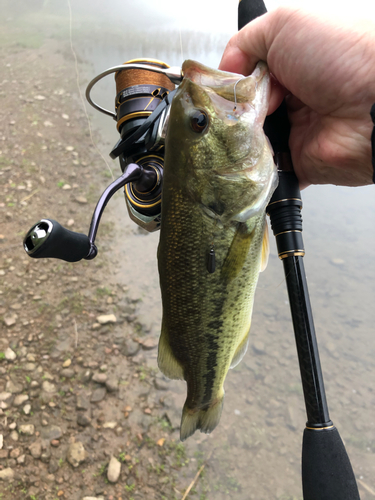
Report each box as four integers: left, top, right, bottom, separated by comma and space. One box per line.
221, 222, 255, 281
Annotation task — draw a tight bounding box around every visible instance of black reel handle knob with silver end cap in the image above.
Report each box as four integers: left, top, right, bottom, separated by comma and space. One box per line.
23, 219, 97, 262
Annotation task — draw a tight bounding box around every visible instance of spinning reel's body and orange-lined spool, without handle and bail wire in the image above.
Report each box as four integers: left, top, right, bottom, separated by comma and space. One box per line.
115, 59, 175, 231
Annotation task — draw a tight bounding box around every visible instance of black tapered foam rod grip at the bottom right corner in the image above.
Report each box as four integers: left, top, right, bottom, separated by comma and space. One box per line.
302, 427, 360, 500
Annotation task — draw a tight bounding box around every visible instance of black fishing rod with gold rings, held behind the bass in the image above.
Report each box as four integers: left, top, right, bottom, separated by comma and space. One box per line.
238, 0, 360, 500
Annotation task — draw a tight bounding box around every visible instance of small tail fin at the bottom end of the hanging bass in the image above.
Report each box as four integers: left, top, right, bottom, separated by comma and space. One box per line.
180, 389, 224, 441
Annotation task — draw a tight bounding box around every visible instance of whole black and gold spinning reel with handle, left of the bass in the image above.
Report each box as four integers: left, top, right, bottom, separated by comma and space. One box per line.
23, 59, 182, 262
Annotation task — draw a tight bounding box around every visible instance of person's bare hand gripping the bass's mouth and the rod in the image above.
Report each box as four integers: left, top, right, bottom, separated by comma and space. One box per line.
220, 8, 375, 188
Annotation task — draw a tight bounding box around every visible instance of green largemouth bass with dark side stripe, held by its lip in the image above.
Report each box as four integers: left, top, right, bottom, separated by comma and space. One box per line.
158, 60, 278, 441
